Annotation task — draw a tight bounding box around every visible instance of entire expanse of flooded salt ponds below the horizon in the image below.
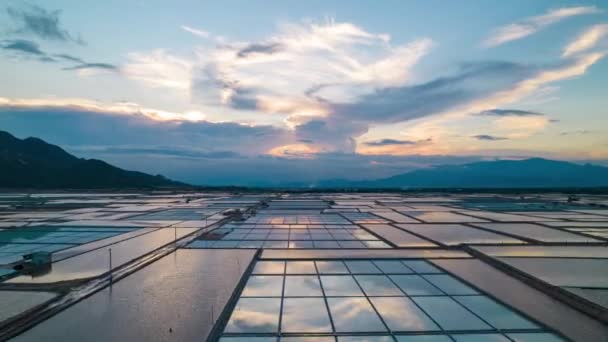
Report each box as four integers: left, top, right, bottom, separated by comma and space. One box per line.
0, 192, 608, 342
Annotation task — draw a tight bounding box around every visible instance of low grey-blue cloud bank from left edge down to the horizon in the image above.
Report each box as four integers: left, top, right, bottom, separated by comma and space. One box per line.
0, 99, 490, 186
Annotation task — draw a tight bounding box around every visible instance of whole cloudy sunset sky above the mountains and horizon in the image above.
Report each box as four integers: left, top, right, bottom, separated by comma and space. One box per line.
0, 0, 608, 185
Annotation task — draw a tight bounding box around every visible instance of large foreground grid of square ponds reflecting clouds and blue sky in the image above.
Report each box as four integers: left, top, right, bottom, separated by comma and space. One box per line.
219, 259, 563, 342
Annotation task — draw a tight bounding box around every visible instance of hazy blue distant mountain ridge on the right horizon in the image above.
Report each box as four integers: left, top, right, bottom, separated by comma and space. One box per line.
316, 158, 608, 188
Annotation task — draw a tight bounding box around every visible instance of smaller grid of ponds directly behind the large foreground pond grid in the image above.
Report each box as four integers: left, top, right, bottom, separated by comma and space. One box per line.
190, 220, 390, 249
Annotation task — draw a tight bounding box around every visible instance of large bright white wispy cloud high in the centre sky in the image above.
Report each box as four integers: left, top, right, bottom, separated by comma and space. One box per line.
124, 20, 433, 116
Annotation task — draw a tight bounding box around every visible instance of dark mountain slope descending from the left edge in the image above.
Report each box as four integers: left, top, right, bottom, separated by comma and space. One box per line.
0, 131, 187, 189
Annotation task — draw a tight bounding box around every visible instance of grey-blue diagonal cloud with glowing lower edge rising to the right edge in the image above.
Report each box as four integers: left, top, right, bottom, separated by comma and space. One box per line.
329, 53, 604, 154
